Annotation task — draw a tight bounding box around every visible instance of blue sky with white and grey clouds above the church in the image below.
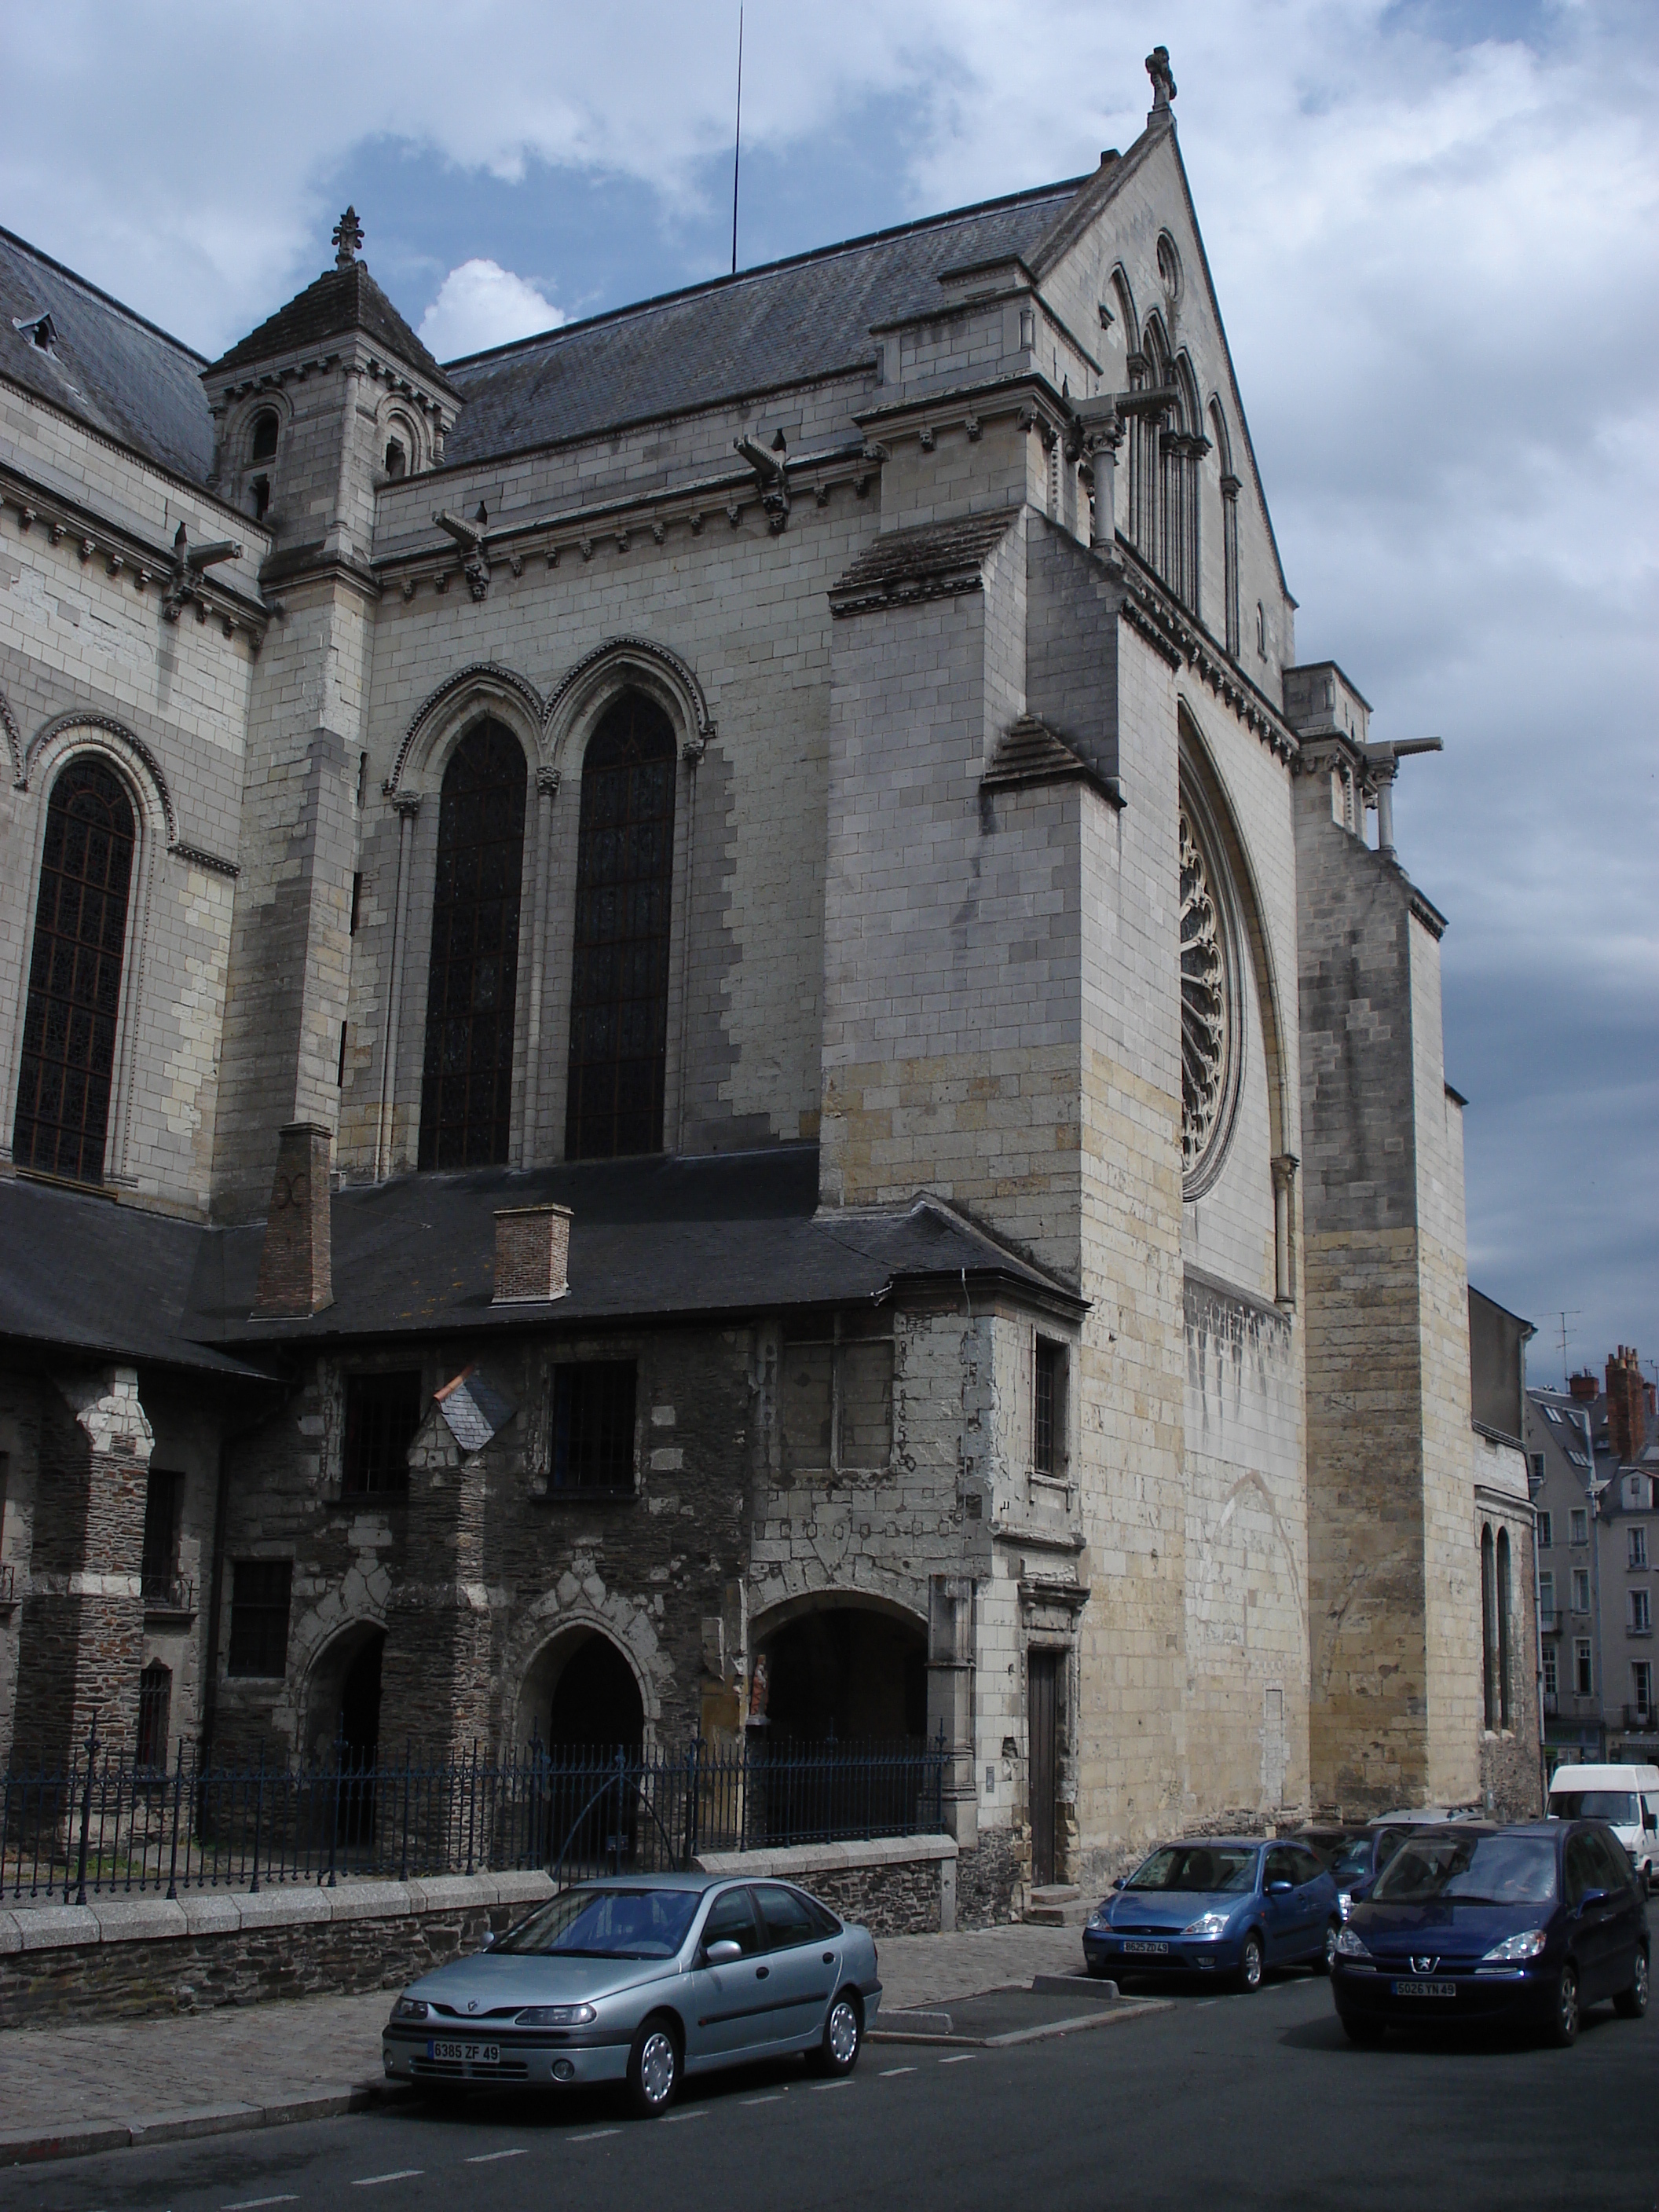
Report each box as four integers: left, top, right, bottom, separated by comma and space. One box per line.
0, 0, 1659, 1380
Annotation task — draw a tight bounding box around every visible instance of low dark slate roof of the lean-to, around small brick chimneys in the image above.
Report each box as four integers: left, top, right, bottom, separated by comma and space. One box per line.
0, 1146, 1084, 1372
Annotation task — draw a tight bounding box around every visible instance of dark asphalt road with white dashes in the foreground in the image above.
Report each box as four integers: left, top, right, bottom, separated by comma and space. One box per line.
0, 1976, 1659, 2212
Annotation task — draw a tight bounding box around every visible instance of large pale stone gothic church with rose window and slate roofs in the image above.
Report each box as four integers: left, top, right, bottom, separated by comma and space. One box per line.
0, 62, 1531, 1909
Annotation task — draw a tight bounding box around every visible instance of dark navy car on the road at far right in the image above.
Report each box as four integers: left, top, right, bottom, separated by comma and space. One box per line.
1331, 1821, 1648, 2044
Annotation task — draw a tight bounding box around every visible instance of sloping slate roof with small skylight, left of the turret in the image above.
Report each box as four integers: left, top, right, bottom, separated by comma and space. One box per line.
0, 230, 212, 485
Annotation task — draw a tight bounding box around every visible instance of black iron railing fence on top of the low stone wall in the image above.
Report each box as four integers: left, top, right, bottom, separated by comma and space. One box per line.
0, 1727, 951, 1905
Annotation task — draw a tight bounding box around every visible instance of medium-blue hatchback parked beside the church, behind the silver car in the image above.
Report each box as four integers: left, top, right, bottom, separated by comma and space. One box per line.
1084, 1836, 1342, 1989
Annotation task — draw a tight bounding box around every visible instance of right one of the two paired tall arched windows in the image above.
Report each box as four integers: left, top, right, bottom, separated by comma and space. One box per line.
564, 692, 675, 1159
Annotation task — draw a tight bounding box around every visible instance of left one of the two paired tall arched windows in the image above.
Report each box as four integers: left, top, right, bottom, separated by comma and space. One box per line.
420, 721, 524, 1168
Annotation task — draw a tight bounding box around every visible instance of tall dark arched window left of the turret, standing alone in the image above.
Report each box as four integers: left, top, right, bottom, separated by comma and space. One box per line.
11, 761, 137, 1184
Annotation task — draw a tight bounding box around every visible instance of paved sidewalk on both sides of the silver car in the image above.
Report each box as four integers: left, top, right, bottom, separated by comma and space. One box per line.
0, 1927, 1082, 2168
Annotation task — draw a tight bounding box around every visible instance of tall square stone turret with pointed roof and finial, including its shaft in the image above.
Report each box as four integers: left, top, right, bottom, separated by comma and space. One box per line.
201, 208, 458, 1219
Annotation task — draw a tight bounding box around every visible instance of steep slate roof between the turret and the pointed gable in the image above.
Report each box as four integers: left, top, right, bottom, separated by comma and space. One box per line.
445, 179, 1084, 463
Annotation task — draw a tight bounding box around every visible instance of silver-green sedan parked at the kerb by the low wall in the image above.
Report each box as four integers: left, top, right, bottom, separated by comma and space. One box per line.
380, 1873, 881, 2117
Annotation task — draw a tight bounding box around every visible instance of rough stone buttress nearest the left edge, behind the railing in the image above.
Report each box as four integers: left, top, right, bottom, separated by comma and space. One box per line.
13, 1367, 150, 1770
